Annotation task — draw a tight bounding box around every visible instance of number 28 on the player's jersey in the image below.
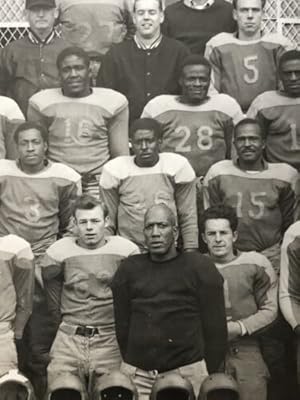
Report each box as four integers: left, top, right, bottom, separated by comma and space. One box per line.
175, 125, 213, 153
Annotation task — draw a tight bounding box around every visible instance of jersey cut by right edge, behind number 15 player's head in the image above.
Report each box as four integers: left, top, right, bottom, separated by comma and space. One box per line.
248, 91, 300, 171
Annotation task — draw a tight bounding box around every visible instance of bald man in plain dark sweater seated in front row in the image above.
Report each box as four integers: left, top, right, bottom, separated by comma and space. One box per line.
112, 204, 227, 400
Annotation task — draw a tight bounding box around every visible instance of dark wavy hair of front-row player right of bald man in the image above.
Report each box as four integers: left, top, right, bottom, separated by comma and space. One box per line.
199, 203, 238, 233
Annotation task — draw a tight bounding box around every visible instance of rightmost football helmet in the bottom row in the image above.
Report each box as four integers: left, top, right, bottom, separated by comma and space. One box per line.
198, 372, 240, 400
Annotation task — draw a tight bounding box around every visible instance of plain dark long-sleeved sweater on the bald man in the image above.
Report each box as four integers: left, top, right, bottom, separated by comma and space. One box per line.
112, 252, 227, 373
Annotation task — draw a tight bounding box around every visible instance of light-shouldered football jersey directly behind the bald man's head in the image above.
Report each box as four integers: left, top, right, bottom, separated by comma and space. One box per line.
100, 153, 198, 248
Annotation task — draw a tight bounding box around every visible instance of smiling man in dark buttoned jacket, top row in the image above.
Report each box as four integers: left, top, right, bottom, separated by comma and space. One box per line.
97, 0, 189, 121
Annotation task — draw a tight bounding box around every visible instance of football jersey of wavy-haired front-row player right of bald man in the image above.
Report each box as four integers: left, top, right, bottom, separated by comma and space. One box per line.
215, 251, 278, 335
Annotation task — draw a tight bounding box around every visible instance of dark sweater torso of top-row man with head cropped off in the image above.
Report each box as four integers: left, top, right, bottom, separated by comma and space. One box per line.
162, 0, 236, 54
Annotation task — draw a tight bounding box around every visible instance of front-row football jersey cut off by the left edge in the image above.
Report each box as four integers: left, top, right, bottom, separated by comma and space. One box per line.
0, 234, 34, 339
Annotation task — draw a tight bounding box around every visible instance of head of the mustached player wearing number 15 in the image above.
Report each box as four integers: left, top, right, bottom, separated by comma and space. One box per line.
234, 118, 265, 170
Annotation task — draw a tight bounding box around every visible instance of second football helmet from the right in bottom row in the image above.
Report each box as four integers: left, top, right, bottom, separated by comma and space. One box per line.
150, 372, 195, 400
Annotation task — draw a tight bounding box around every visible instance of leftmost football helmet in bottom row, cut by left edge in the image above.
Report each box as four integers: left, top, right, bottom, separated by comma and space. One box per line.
0, 370, 35, 400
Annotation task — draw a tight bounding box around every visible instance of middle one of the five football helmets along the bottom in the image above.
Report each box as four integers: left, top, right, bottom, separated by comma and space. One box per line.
93, 371, 138, 400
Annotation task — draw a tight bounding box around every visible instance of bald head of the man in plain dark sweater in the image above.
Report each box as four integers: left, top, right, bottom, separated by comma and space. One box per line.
144, 203, 178, 261
